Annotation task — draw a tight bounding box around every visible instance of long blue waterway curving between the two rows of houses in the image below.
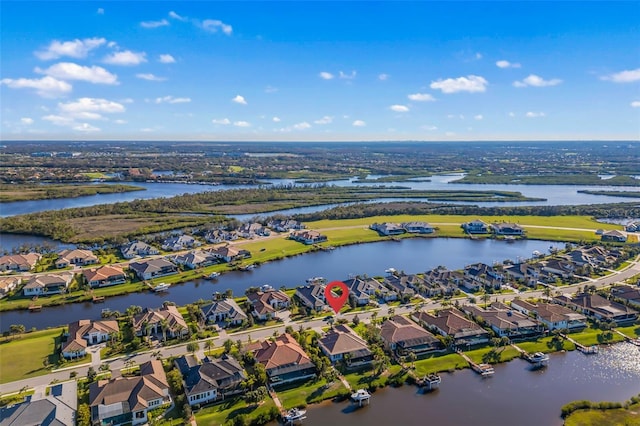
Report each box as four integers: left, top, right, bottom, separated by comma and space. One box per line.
0, 238, 564, 330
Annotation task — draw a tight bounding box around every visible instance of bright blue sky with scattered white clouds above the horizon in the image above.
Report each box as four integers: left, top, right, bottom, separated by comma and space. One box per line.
0, 1, 640, 141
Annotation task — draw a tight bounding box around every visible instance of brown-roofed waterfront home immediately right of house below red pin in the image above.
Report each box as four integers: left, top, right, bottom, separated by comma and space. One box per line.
380, 315, 442, 356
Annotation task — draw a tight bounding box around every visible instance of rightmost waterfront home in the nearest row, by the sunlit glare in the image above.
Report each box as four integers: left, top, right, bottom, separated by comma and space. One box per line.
553, 293, 638, 326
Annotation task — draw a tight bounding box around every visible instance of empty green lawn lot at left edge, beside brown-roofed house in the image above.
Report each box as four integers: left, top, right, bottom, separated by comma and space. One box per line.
0, 328, 62, 383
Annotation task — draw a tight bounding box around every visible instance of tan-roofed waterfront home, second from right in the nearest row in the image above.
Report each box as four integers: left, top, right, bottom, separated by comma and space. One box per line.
511, 299, 587, 331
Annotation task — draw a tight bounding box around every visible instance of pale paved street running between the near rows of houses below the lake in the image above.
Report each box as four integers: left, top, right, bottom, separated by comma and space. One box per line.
0, 256, 640, 394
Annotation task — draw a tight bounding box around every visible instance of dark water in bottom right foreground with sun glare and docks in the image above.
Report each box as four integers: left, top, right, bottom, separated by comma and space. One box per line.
303, 343, 640, 426
